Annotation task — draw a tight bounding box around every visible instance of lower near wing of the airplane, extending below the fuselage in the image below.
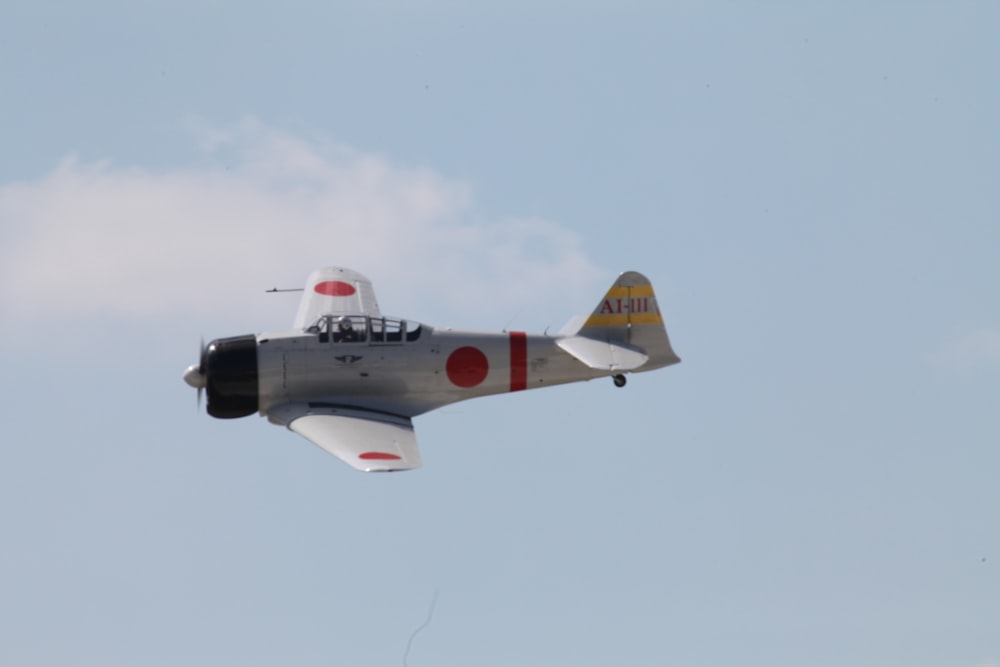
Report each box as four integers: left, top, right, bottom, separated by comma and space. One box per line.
268, 403, 421, 472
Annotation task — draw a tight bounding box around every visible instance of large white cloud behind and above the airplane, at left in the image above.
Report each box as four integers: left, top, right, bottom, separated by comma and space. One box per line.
0, 120, 606, 336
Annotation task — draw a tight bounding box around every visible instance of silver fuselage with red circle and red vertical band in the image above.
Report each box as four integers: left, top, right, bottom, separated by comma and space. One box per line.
257, 325, 624, 417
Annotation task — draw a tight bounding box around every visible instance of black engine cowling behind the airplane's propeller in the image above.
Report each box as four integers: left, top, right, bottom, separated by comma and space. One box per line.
201, 336, 260, 419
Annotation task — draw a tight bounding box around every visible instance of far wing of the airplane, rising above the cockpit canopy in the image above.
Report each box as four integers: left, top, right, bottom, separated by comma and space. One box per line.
292, 266, 381, 329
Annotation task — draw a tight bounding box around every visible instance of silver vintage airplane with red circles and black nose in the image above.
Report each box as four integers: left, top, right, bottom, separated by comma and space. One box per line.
184, 266, 680, 472
